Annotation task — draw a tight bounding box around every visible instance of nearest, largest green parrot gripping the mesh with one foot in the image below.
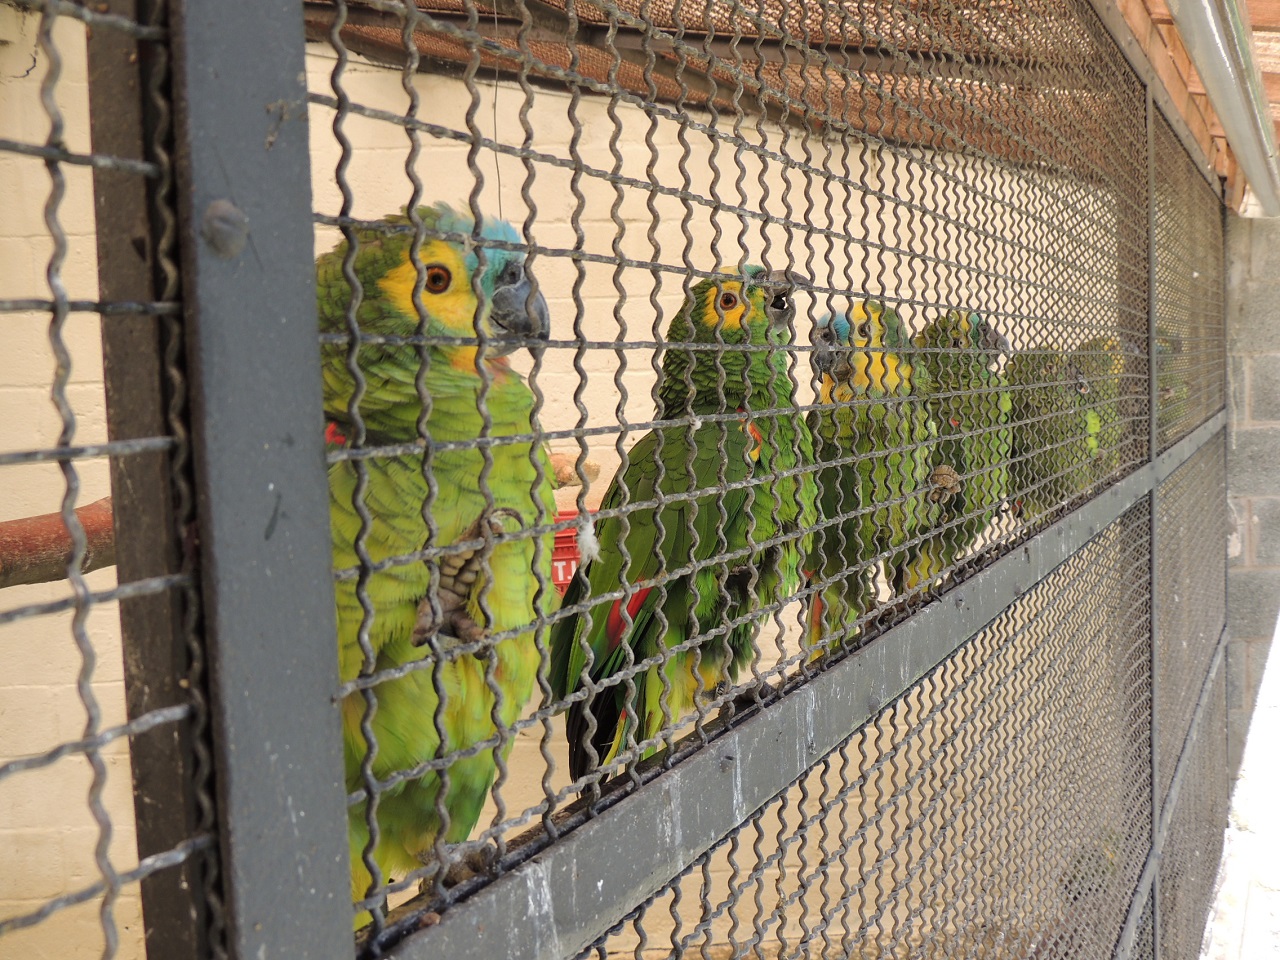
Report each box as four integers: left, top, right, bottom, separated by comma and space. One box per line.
316, 204, 556, 927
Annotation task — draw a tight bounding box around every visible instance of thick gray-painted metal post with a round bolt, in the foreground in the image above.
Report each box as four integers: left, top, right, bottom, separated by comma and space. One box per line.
172, 0, 352, 960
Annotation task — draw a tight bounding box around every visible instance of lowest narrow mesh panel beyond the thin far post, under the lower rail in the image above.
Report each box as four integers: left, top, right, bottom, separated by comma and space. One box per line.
1160, 669, 1230, 960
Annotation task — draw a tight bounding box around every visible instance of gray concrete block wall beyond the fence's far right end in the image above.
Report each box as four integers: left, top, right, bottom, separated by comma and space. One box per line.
1226, 215, 1280, 776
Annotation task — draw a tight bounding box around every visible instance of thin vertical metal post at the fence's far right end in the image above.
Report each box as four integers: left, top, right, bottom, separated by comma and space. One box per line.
1147, 84, 1162, 960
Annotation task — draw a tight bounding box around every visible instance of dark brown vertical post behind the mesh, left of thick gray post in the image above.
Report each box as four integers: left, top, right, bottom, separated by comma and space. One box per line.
87, 0, 207, 960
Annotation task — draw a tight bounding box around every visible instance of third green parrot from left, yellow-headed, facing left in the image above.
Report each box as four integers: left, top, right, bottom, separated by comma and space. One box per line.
806, 300, 956, 653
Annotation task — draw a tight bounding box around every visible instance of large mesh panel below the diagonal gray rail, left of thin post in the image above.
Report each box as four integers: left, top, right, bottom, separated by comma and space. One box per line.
570, 506, 1151, 957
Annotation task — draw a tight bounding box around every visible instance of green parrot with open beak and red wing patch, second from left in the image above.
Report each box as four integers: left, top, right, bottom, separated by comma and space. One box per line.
550, 266, 817, 780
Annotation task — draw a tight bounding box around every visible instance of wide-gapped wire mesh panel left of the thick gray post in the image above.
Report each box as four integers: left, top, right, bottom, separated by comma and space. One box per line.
0, 3, 220, 957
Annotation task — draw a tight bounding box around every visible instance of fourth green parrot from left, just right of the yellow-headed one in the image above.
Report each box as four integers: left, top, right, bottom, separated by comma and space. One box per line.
895, 310, 1012, 593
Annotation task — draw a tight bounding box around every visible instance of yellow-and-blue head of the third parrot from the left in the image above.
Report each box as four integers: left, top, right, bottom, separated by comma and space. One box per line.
813, 300, 911, 403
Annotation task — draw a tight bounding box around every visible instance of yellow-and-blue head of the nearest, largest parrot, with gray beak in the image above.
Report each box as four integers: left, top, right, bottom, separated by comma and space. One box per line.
356, 204, 550, 364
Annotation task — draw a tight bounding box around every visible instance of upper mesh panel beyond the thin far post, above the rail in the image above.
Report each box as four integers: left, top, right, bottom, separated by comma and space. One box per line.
1153, 115, 1226, 449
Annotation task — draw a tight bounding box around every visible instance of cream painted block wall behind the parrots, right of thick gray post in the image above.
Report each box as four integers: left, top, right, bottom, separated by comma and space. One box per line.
307, 44, 1116, 503
